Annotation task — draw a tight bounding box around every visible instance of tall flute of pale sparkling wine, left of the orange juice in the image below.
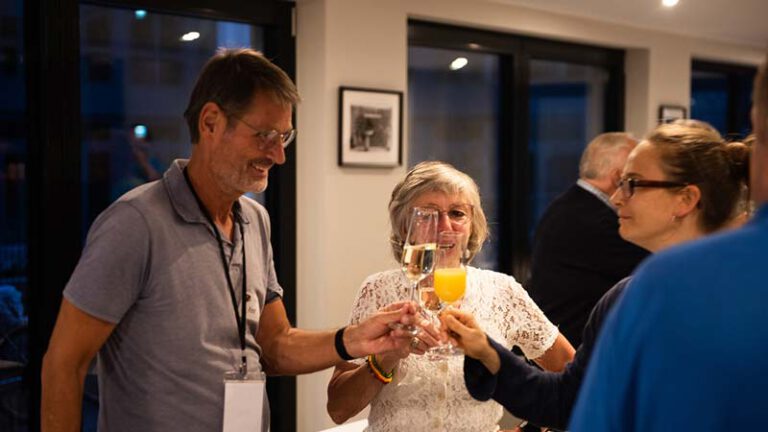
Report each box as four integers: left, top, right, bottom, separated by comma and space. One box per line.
400, 207, 439, 334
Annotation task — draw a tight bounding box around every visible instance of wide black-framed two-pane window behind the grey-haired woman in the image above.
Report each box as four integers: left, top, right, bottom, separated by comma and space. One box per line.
408, 21, 624, 281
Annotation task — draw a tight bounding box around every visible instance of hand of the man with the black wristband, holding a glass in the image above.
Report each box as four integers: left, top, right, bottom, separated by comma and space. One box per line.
344, 301, 419, 357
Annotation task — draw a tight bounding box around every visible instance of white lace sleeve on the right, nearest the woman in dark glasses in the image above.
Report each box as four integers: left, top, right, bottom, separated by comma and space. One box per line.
492, 276, 558, 359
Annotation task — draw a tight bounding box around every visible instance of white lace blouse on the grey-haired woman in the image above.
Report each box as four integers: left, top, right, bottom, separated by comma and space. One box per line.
350, 267, 558, 432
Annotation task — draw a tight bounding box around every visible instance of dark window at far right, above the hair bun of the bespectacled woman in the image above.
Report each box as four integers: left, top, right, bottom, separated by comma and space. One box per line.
691, 60, 757, 139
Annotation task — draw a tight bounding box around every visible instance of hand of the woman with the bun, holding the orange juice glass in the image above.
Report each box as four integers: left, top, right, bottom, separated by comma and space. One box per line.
440, 309, 501, 374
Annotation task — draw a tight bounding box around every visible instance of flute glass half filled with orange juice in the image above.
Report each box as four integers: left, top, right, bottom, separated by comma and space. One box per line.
431, 231, 469, 357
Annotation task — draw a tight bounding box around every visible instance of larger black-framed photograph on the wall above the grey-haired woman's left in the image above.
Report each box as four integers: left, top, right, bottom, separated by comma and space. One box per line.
339, 87, 403, 167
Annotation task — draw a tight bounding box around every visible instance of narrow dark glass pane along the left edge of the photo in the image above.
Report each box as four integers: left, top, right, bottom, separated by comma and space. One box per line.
0, 0, 28, 432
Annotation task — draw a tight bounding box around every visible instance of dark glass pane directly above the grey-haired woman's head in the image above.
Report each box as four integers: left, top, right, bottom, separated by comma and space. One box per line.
408, 47, 499, 269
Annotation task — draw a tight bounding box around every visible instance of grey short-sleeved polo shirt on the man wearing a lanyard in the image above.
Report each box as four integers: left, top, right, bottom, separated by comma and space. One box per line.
64, 160, 282, 432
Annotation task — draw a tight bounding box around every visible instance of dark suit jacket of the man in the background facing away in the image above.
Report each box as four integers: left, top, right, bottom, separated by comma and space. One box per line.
527, 185, 648, 347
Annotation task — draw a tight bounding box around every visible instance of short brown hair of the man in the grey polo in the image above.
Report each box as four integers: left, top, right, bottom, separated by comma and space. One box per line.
184, 48, 300, 144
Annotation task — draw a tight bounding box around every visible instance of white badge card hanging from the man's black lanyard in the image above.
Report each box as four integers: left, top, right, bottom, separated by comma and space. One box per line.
222, 373, 269, 432
